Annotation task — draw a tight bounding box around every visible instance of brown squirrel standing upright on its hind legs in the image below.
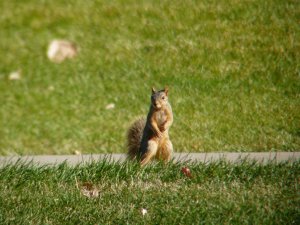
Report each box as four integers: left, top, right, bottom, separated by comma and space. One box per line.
127, 87, 173, 166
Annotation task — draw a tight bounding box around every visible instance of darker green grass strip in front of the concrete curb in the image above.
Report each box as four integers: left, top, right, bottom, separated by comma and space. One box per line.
0, 160, 300, 224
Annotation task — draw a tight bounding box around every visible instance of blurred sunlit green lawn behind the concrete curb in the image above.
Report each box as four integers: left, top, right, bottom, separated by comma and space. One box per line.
0, 0, 300, 155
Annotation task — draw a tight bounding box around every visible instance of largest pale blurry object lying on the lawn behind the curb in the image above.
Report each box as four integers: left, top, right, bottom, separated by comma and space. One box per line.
47, 40, 78, 63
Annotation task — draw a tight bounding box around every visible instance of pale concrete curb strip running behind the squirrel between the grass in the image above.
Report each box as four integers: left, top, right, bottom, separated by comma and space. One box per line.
0, 152, 300, 167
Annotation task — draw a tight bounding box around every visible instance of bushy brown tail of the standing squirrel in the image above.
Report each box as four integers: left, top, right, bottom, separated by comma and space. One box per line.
127, 118, 146, 159
